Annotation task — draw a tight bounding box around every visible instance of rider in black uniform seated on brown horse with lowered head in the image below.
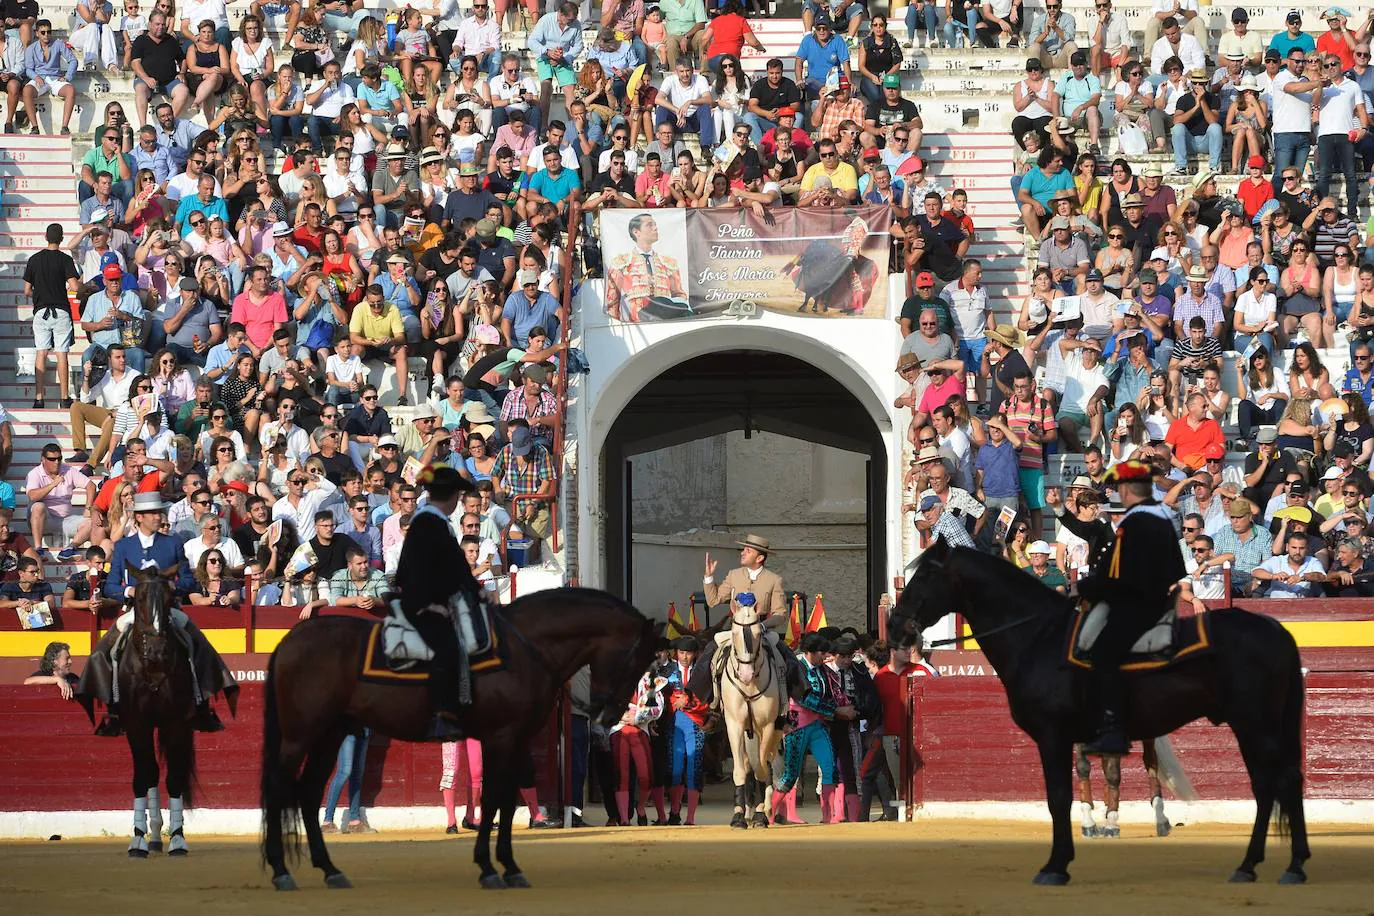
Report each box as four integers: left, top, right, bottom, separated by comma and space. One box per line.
396, 466, 482, 739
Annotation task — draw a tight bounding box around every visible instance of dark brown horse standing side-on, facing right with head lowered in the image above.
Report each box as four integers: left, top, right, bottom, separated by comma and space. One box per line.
262, 588, 664, 890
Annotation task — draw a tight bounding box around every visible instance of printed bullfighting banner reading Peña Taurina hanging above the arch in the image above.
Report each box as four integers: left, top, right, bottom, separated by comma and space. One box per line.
600, 206, 892, 321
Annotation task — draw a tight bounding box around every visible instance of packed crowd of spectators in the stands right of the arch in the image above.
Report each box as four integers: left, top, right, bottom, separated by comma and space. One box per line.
897, 0, 1374, 607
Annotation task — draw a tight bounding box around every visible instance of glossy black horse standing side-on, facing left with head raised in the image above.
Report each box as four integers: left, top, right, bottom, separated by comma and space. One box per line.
889, 538, 1311, 884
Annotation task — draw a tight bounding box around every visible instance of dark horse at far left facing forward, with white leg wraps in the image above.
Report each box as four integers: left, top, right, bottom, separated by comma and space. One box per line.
118, 566, 195, 858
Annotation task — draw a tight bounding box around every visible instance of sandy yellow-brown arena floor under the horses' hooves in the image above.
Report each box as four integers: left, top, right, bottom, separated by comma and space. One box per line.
0, 821, 1374, 916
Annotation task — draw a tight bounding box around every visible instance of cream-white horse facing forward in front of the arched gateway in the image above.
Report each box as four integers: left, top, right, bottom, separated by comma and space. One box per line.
716, 595, 787, 829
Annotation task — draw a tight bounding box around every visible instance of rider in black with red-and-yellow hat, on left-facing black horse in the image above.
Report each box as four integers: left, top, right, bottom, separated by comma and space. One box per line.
1079, 461, 1187, 755
